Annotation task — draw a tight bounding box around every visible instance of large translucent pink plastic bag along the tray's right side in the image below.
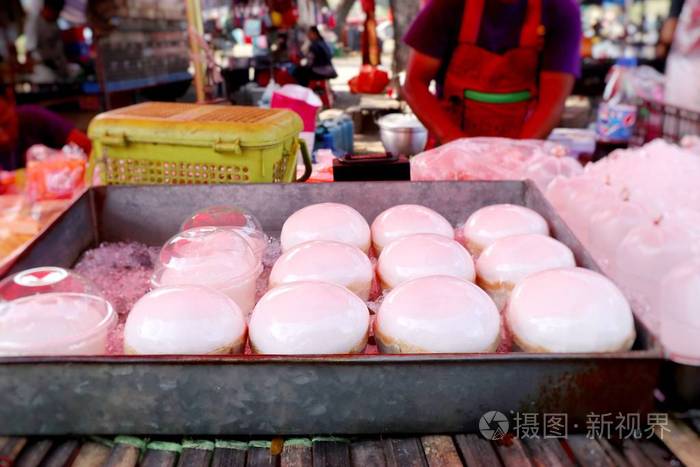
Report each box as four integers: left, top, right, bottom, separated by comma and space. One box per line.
547, 138, 700, 329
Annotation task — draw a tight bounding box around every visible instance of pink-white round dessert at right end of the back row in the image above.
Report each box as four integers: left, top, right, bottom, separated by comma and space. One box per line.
462, 204, 549, 256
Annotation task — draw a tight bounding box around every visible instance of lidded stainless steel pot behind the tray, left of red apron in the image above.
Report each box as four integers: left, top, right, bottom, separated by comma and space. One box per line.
377, 114, 428, 156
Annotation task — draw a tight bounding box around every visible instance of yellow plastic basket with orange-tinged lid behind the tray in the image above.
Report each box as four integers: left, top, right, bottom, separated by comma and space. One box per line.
88, 102, 311, 185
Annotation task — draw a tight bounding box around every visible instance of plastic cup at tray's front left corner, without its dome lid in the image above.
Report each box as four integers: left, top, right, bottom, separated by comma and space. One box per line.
0, 292, 117, 356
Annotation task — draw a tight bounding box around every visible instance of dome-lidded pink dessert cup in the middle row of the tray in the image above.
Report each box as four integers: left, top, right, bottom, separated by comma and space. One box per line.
151, 227, 263, 314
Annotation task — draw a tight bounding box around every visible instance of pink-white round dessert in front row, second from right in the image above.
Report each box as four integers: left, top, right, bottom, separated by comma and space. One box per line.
374, 276, 501, 353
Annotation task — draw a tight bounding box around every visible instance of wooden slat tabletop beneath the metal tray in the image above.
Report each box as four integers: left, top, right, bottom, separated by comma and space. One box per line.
0, 431, 700, 467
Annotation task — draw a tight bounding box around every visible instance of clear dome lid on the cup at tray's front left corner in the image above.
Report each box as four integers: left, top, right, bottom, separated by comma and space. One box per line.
0, 266, 102, 301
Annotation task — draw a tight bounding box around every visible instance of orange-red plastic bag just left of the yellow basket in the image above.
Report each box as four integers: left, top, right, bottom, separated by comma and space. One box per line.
27, 145, 87, 201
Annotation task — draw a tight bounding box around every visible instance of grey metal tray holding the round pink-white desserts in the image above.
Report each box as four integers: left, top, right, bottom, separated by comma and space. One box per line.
0, 182, 661, 435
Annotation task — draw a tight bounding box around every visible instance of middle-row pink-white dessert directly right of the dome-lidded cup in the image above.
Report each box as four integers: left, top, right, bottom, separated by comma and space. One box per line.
270, 240, 374, 301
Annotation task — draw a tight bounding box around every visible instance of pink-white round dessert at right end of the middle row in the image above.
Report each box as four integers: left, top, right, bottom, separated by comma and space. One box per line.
476, 234, 576, 310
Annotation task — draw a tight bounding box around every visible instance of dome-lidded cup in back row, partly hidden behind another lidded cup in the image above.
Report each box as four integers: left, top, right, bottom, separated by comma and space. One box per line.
180, 206, 267, 259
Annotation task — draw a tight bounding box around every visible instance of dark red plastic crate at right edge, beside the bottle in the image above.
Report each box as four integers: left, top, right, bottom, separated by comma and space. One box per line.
630, 100, 700, 146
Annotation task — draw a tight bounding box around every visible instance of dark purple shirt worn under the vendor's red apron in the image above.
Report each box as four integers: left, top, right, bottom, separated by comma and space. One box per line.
404, 0, 581, 88
